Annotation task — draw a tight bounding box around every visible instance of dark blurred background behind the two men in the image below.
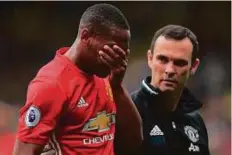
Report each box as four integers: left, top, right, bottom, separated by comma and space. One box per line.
0, 1, 231, 155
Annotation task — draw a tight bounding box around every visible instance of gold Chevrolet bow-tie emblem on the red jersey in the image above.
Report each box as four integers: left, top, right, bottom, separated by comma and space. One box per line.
82, 111, 115, 132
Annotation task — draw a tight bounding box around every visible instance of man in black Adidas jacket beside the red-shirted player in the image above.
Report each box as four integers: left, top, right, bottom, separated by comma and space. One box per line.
129, 25, 210, 155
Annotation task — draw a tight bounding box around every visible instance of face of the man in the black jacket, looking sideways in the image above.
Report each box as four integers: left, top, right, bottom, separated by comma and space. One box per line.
148, 36, 199, 91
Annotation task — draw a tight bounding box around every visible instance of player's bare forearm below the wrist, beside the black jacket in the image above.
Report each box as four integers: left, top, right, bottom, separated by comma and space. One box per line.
112, 86, 143, 151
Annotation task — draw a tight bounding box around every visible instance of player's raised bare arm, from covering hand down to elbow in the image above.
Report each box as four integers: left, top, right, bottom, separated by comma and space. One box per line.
99, 45, 143, 149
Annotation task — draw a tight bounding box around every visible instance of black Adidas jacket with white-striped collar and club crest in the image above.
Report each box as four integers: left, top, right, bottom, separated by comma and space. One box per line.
129, 77, 210, 155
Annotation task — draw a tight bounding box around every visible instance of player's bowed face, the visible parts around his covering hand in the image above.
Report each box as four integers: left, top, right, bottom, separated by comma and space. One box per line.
91, 29, 130, 77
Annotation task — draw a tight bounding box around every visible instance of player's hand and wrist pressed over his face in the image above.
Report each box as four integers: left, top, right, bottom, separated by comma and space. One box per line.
99, 45, 130, 88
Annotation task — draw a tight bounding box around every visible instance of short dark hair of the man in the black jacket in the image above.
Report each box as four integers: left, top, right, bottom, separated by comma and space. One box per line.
150, 25, 199, 62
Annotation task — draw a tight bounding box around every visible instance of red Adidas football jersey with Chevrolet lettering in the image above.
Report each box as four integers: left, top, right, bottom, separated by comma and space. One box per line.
17, 48, 116, 155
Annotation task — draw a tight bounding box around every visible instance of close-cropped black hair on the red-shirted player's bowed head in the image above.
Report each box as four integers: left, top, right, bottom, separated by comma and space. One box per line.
80, 3, 130, 31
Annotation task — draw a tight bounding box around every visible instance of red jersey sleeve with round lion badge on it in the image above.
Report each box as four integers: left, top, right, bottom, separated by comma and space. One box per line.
17, 81, 66, 145
